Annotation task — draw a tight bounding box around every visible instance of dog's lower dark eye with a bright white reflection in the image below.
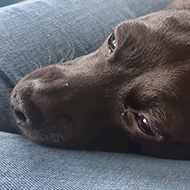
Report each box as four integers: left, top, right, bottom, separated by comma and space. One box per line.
136, 114, 153, 136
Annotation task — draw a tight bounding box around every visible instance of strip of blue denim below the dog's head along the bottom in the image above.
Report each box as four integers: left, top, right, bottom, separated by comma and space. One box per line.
0, 132, 190, 190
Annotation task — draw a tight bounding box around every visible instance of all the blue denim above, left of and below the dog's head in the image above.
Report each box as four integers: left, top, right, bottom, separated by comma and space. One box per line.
0, 0, 190, 190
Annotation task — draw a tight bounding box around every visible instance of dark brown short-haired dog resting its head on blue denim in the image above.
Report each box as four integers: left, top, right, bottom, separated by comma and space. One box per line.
10, 1, 190, 159
